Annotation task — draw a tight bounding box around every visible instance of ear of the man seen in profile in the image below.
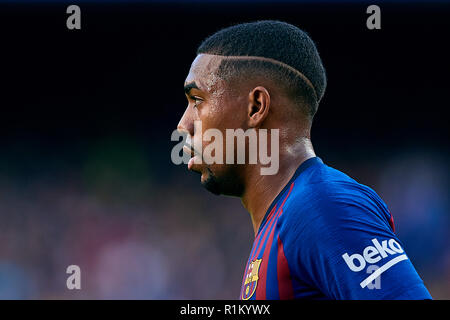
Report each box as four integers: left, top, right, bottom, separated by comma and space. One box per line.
247, 86, 270, 128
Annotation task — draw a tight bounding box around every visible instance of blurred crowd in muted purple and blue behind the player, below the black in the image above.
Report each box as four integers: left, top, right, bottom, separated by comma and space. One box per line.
0, 141, 450, 299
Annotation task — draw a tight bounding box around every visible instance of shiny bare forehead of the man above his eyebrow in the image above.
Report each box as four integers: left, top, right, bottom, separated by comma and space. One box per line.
185, 54, 223, 91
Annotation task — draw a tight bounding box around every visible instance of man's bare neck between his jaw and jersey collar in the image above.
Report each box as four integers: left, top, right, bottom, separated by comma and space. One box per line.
241, 138, 315, 236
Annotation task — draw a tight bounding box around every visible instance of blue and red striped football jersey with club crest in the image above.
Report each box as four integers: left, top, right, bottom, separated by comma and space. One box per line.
240, 157, 432, 300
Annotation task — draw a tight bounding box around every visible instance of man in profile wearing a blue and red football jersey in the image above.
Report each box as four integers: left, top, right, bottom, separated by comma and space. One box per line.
178, 21, 431, 300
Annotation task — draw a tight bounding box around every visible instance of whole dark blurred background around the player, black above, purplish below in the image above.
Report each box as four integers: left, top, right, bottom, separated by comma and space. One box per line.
0, 1, 450, 299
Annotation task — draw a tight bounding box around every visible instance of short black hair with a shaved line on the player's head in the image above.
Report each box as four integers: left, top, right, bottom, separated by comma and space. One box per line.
197, 20, 327, 116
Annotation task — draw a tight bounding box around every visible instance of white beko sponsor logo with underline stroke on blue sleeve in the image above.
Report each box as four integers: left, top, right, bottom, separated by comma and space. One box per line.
342, 239, 408, 288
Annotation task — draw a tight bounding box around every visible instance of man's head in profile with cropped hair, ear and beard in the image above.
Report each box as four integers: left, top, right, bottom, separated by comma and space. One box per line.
178, 21, 326, 196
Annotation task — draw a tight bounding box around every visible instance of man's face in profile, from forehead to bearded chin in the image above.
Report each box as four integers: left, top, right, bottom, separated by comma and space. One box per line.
177, 54, 246, 196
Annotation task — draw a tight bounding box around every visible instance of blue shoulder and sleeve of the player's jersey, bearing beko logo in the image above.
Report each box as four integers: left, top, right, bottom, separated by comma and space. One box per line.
277, 160, 430, 299
